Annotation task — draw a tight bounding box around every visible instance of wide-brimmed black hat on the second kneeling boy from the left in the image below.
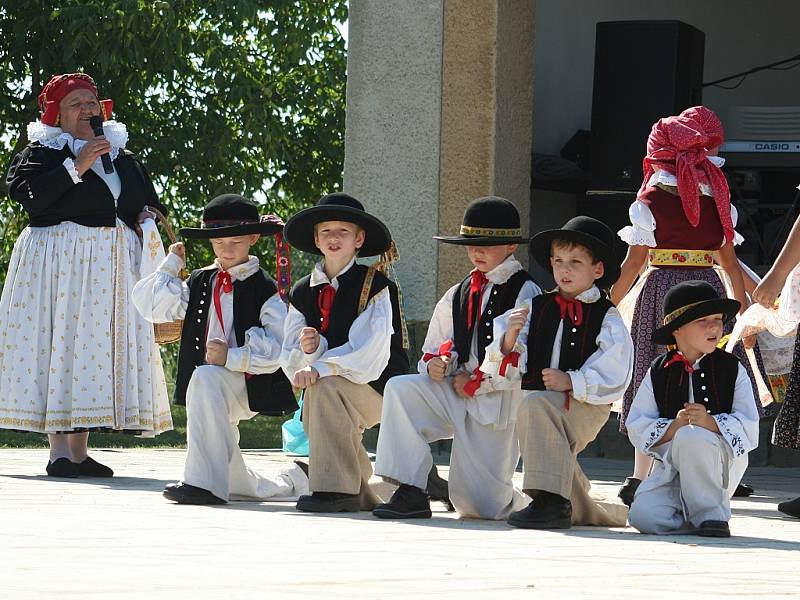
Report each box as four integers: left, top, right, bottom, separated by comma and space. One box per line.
283, 192, 392, 256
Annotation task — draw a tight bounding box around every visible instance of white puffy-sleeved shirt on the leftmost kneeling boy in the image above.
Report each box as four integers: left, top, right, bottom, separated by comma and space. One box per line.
132, 253, 286, 375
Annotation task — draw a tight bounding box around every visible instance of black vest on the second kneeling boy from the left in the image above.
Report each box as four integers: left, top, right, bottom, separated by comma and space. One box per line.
289, 264, 408, 394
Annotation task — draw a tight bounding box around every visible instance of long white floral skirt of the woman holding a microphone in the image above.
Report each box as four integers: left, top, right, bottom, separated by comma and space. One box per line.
0, 220, 172, 435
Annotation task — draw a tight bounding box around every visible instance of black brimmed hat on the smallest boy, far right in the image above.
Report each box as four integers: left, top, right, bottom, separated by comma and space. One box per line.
653, 280, 741, 345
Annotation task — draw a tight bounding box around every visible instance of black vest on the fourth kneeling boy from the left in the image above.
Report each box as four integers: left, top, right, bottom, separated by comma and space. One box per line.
522, 292, 614, 390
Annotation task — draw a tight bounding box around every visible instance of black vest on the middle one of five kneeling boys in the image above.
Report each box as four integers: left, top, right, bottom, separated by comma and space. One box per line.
453, 271, 533, 365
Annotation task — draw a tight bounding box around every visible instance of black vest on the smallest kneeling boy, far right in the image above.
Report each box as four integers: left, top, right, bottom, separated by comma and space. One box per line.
650, 348, 740, 419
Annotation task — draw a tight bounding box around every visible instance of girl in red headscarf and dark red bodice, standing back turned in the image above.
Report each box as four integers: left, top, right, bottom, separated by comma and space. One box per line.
611, 106, 762, 505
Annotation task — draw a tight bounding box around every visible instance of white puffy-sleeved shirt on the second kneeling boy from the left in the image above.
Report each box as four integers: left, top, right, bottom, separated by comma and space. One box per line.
280, 260, 394, 384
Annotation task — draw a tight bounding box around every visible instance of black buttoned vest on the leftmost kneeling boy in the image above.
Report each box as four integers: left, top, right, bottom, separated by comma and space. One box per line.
174, 269, 297, 416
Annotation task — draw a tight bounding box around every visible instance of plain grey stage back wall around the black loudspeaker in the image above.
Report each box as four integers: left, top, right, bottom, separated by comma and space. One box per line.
533, 0, 800, 154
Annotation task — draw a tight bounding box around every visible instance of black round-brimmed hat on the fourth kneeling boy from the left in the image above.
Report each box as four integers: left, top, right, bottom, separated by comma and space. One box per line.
530, 215, 620, 289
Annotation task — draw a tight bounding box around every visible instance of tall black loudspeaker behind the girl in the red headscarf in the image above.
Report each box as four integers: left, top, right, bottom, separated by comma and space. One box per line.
589, 21, 705, 192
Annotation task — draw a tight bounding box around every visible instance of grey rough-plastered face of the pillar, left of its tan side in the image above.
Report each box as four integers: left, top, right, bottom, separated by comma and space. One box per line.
344, 0, 443, 320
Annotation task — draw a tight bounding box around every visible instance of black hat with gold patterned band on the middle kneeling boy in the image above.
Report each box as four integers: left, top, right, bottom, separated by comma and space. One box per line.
433, 196, 528, 246
